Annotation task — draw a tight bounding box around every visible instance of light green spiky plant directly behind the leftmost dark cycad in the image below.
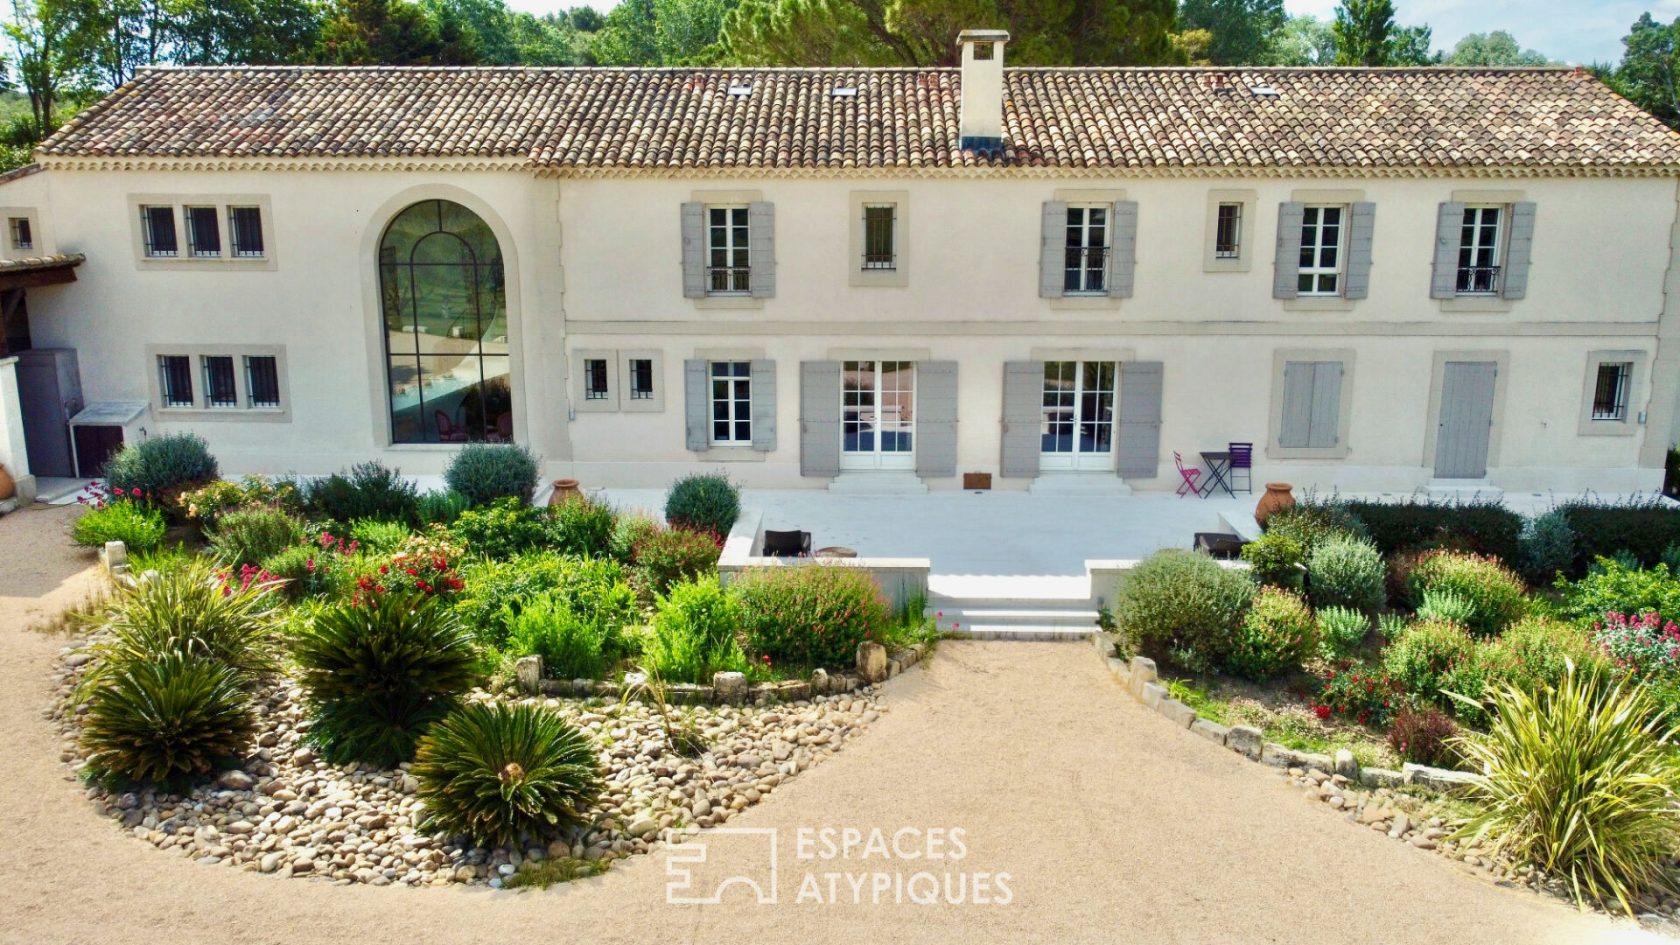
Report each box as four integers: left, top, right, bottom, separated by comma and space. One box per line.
81, 558, 281, 698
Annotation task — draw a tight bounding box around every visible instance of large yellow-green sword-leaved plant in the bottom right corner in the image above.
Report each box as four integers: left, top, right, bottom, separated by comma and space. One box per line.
1455, 669, 1680, 915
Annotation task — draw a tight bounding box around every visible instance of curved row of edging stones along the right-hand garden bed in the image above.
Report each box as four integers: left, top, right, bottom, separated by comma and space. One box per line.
1092, 632, 1475, 794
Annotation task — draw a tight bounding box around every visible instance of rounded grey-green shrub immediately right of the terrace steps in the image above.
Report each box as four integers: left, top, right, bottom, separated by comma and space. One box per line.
1114, 550, 1255, 673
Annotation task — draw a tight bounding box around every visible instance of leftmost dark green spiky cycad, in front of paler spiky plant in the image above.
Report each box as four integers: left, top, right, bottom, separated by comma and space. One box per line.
82, 652, 257, 790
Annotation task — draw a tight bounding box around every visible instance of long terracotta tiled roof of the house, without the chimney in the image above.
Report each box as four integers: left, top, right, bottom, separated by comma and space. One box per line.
39, 67, 1680, 173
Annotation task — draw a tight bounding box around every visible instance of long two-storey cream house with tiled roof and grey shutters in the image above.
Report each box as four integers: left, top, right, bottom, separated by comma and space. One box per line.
0, 32, 1680, 493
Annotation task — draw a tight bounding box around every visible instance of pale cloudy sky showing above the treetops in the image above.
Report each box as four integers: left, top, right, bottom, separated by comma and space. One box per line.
507, 0, 1680, 62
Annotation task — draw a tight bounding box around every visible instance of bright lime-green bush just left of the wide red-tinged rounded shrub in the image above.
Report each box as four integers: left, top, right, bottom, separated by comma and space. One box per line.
642, 577, 748, 683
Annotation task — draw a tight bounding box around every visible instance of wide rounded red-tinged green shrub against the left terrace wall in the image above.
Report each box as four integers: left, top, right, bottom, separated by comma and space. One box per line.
731, 563, 890, 666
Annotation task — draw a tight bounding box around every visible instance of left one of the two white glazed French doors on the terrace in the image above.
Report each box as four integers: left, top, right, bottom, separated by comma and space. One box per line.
840, 362, 916, 469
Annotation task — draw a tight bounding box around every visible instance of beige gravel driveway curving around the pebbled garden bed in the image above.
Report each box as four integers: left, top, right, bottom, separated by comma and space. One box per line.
0, 509, 1645, 945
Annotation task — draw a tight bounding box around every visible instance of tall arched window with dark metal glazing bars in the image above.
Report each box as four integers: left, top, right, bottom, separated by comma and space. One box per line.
380, 200, 514, 442
